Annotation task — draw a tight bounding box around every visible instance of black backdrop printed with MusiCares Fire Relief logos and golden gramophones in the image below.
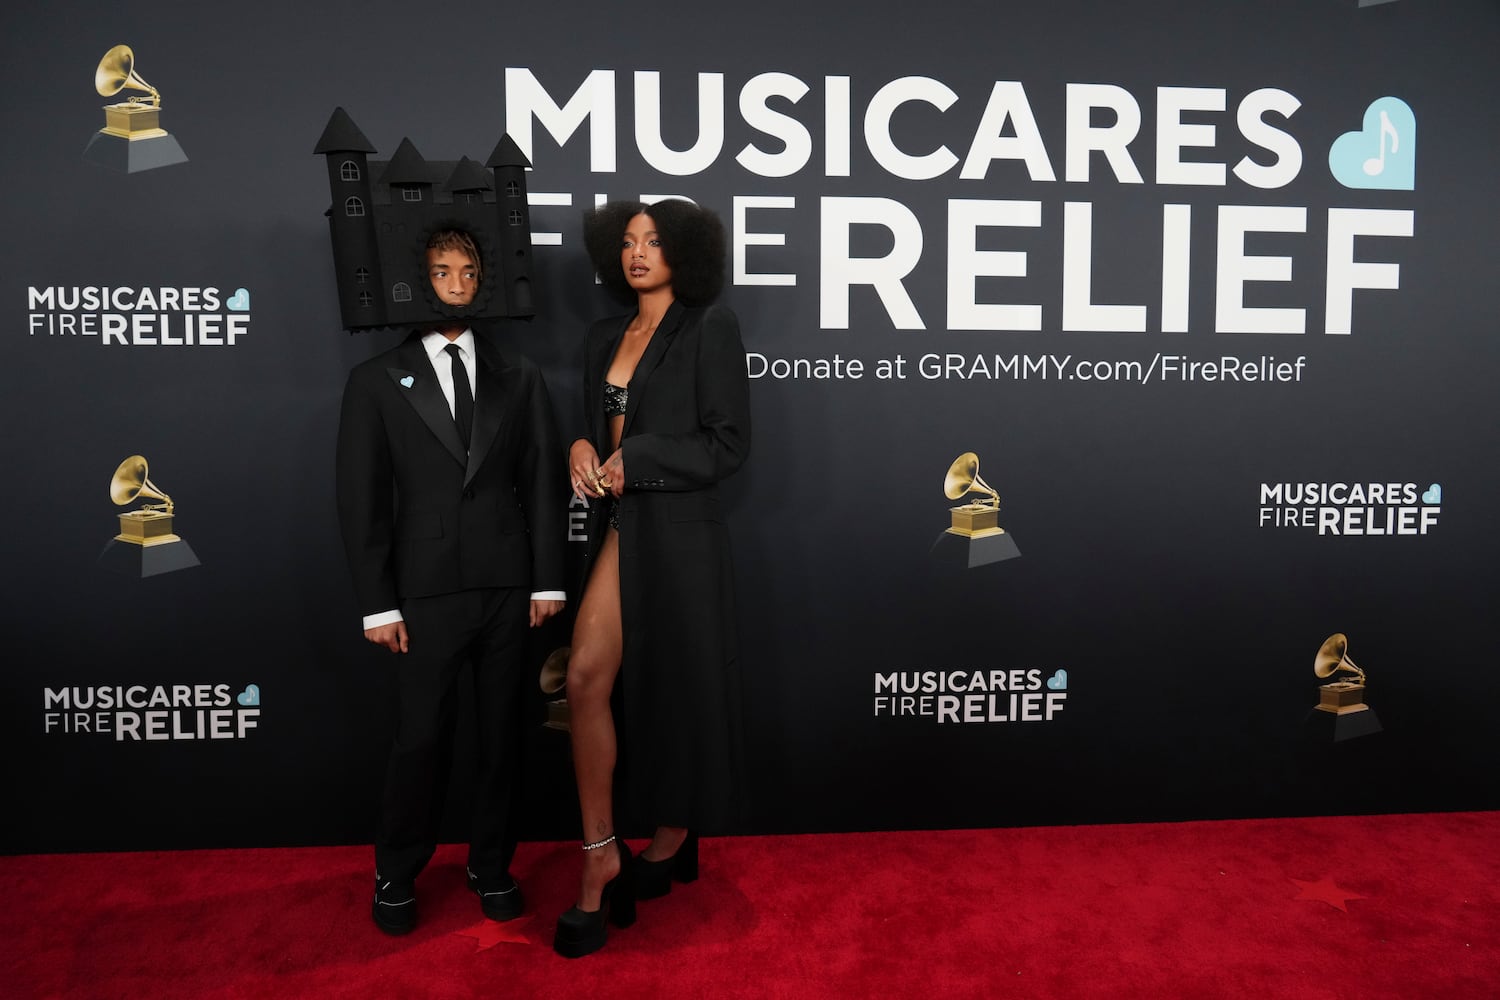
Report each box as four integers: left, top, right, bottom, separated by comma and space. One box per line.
0, 0, 1500, 852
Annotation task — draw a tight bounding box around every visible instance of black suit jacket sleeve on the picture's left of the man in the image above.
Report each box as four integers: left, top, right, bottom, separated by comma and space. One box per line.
335, 372, 399, 615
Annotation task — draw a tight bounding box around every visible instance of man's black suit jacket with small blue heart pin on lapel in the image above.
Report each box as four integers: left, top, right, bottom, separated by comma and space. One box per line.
338, 331, 567, 615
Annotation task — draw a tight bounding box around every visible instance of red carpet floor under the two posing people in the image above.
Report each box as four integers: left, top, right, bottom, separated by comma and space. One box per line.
0, 813, 1500, 1000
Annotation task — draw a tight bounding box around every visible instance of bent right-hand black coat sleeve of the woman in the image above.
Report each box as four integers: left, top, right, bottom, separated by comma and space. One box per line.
621, 306, 750, 490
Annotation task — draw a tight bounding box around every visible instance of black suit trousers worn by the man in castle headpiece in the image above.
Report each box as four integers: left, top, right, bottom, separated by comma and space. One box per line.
375, 588, 531, 882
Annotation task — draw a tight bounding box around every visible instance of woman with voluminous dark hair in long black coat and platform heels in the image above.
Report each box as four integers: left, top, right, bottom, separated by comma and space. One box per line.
554, 199, 750, 958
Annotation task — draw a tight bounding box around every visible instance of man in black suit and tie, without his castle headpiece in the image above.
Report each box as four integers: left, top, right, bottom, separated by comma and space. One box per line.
338, 231, 567, 934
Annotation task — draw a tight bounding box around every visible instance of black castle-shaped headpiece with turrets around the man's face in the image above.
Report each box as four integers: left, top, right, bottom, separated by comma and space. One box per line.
314, 108, 536, 331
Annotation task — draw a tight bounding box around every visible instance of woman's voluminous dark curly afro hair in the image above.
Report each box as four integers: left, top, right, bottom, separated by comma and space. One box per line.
584, 198, 725, 306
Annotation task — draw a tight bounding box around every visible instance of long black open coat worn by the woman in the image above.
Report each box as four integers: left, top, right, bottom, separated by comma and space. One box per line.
584, 303, 750, 831
